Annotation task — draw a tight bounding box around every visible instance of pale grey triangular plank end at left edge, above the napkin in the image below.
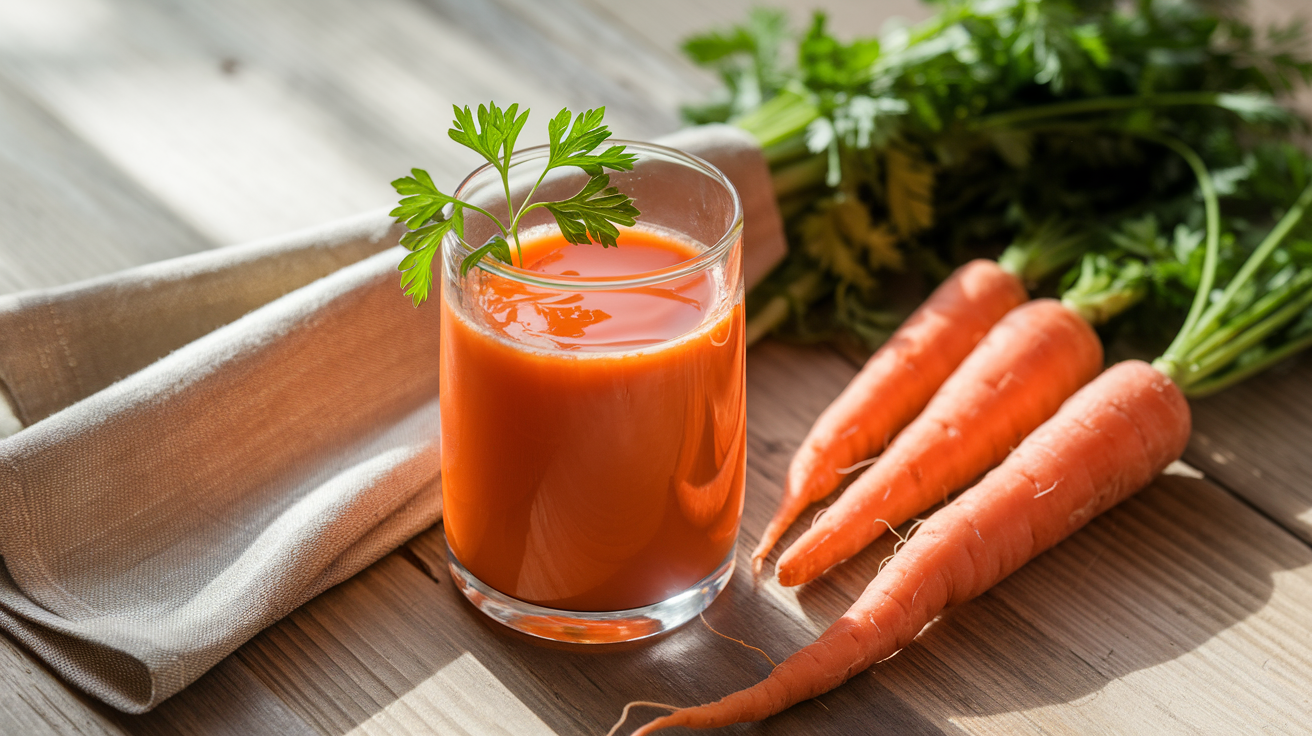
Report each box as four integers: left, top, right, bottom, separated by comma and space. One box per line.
0, 71, 211, 294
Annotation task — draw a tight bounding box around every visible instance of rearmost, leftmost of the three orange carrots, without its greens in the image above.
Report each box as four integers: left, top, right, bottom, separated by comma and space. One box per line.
752, 258, 1029, 573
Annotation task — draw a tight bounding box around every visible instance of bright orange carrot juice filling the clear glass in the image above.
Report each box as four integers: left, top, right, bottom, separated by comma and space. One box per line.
441, 230, 747, 611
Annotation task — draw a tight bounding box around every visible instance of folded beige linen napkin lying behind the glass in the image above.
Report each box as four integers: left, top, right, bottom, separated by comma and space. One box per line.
0, 126, 783, 712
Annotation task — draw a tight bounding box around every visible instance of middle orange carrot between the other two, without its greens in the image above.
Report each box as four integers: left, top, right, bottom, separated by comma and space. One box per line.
777, 299, 1102, 585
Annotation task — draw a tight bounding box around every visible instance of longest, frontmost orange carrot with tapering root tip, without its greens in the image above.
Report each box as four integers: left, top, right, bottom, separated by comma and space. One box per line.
634, 361, 1190, 736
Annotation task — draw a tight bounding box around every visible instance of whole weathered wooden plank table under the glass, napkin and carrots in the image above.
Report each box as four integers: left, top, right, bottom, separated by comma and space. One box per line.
0, 0, 1312, 736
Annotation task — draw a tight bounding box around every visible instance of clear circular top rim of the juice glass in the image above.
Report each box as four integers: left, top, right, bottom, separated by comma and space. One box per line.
442, 139, 743, 291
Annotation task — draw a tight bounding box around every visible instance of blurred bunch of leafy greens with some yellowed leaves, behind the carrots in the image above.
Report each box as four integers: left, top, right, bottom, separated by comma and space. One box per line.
685, 0, 1312, 346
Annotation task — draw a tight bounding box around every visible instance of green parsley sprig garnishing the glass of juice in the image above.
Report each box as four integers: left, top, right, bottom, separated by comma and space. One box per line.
391, 102, 639, 307
